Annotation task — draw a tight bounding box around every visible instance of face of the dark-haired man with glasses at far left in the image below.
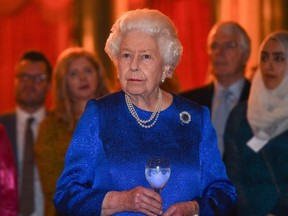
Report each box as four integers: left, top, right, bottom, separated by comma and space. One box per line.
15, 60, 50, 109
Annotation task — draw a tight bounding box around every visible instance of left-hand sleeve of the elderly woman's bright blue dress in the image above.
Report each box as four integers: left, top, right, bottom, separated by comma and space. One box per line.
54, 100, 110, 215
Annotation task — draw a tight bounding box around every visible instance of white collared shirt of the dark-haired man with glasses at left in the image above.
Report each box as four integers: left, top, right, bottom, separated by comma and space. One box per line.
16, 107, 46, 216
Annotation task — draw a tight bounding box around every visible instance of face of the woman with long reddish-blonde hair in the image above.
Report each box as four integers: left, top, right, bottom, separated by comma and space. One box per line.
66, 57, 98, 101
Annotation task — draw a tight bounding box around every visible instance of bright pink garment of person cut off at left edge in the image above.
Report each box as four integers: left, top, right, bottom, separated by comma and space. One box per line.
0, 124, 18, 216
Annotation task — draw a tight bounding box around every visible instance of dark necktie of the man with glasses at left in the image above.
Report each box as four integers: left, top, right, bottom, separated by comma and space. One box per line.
20, 118, 34, 216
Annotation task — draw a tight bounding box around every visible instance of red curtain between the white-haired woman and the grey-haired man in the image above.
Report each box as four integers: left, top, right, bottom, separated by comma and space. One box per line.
151, 0, 213, 91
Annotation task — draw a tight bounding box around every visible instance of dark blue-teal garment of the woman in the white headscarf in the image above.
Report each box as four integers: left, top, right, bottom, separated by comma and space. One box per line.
224, 102, 288, 216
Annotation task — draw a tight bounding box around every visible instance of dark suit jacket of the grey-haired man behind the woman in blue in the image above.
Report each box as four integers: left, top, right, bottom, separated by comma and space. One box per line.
180, 79, 250, 112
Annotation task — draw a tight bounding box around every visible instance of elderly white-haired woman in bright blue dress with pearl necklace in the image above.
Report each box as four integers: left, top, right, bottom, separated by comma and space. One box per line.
54, 9, 236, 216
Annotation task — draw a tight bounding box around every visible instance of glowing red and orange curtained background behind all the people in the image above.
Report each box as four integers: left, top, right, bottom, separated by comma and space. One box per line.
0, 0, 288, 112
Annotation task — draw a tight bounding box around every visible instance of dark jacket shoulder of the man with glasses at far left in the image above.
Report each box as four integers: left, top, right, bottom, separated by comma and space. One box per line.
0, 112, 17, 159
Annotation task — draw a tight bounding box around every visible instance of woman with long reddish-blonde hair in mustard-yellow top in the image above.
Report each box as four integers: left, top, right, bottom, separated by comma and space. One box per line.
35, 47, 109, 215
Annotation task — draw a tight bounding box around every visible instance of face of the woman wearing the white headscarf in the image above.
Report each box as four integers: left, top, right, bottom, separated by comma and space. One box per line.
260, 39, 287, 89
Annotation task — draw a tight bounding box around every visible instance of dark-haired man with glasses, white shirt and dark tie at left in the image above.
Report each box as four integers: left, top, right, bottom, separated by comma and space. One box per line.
0, 50, 52, 216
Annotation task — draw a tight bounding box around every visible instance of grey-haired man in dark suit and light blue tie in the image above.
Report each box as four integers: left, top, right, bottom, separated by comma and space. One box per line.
181, 22, 251, 156
